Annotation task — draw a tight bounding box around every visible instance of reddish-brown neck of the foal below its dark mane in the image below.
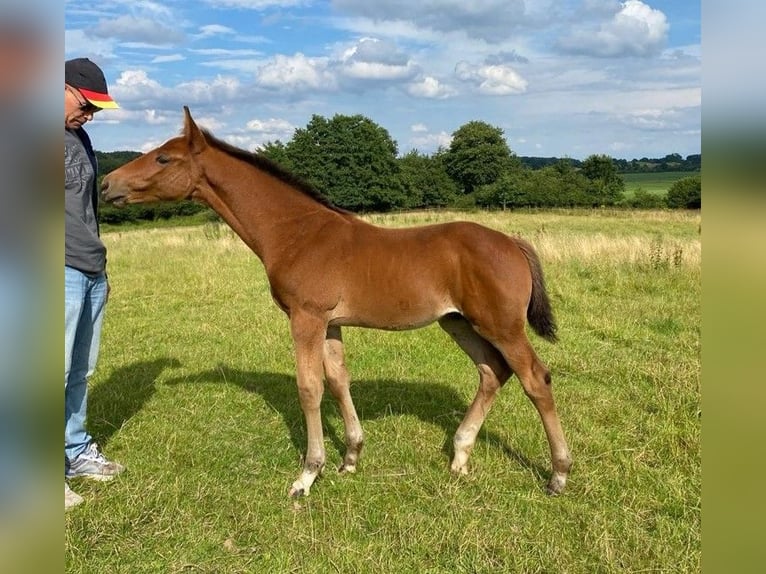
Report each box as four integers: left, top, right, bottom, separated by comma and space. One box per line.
195, 149, 341, 268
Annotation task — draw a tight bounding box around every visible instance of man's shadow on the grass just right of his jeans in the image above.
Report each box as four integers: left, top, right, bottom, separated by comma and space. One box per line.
88, 358, 181, 446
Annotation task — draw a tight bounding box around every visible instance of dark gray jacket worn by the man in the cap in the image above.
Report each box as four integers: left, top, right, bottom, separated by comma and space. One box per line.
64, 128, 106, 275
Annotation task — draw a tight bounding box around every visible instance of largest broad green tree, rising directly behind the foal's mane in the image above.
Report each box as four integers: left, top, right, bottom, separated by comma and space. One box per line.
284, 114, 407, 211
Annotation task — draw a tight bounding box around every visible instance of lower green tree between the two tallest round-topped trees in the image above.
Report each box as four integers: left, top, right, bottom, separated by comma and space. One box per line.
399, 150, 457, 209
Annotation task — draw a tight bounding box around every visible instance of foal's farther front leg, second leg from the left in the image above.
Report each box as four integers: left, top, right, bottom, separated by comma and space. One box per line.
323, 327, 364, 472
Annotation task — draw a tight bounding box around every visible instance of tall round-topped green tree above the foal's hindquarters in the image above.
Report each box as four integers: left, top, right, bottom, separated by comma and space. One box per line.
442, 121, 521, 194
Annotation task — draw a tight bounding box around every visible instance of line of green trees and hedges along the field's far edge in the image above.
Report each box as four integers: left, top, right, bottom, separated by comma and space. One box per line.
97, 114, 702, 223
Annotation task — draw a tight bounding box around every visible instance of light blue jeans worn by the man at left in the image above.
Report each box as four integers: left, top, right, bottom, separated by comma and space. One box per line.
64, 266, 107, 460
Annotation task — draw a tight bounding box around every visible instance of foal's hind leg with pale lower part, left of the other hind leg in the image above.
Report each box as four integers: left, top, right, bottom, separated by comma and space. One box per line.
439, 314, 512, 474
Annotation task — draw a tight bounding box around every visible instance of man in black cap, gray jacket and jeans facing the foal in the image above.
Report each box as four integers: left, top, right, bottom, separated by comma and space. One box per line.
64, 58, 124, 509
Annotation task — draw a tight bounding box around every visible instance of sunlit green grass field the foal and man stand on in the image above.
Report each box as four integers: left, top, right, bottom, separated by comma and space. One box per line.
65, 210, 701, 574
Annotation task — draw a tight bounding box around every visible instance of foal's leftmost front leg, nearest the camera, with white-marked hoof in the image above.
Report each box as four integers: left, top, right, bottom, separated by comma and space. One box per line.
290, 313, 326, 498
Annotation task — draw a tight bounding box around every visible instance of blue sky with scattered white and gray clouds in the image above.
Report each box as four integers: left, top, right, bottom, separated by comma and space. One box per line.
64, 0, 702, 159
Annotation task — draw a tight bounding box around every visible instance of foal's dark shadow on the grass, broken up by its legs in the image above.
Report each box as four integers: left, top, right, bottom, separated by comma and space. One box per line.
160, 365, 550, 480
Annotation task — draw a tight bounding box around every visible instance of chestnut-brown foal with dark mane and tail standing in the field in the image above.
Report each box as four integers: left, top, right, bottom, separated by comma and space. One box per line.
102, 107, 572, 496
